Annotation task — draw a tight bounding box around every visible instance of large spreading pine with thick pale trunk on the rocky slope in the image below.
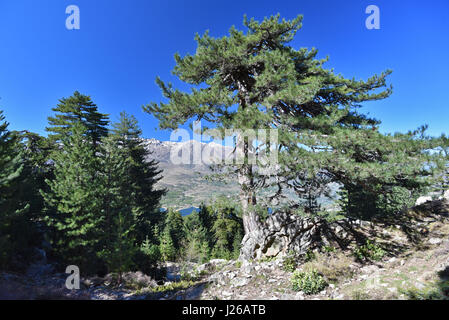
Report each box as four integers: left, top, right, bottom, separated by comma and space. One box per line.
144, 15, 434, 241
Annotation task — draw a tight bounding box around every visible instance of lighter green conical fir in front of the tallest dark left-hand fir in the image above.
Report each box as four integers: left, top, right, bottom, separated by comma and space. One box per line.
42, 122, 103, 273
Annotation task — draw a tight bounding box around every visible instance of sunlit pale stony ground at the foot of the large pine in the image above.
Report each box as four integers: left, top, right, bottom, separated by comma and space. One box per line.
200, 231, 449, 300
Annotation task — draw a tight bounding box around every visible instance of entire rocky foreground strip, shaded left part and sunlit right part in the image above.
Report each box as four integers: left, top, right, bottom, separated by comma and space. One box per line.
0, 202, 449, 300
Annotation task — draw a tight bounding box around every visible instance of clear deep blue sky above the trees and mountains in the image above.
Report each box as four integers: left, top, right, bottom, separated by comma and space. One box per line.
0, 0, 449, 140
